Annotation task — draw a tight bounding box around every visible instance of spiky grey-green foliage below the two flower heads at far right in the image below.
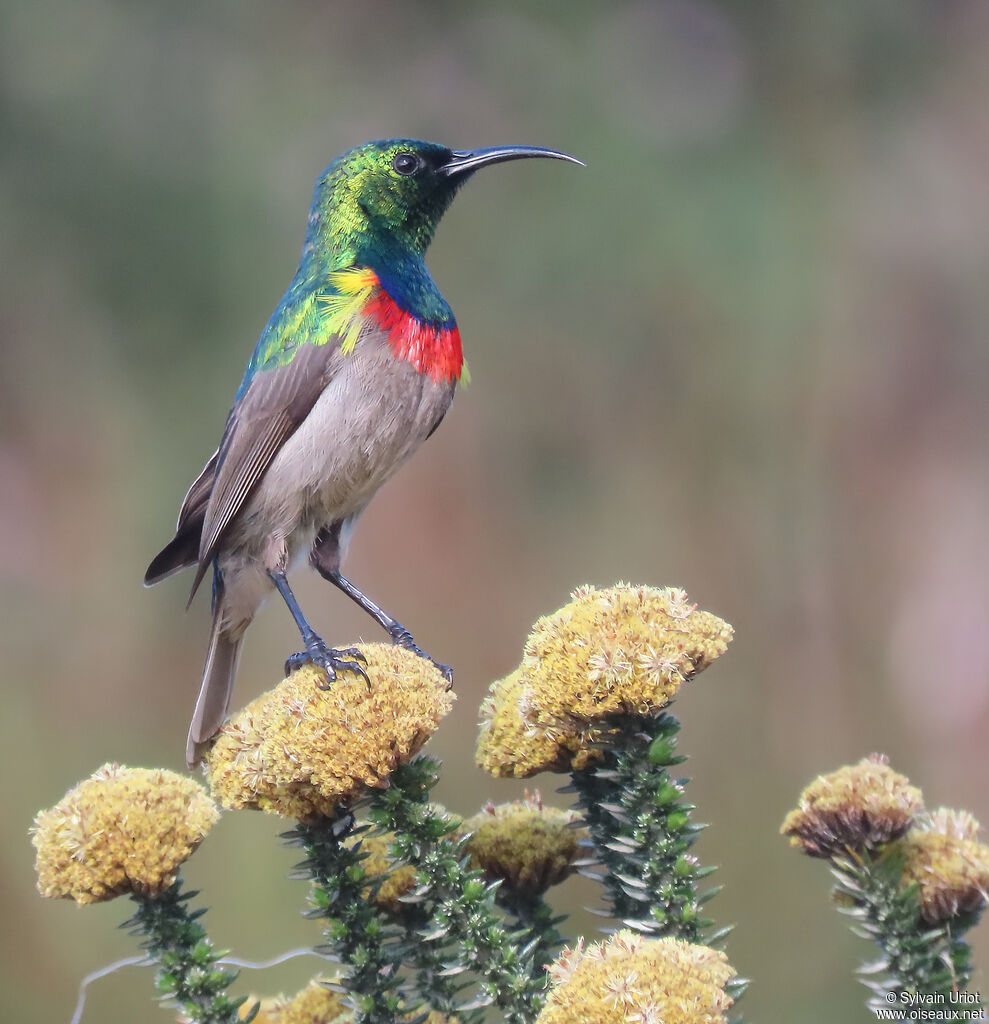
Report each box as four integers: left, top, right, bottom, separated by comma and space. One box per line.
831, 844, 978, 1020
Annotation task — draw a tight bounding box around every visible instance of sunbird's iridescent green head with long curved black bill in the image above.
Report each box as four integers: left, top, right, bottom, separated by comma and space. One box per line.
307, 138, 581, 262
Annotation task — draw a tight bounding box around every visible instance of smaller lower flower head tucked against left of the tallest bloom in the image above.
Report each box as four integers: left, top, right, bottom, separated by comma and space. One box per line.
475, 669, 601, 778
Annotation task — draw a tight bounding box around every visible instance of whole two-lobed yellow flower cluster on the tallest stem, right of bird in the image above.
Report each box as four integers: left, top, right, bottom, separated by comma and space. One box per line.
477, 584, 732, 777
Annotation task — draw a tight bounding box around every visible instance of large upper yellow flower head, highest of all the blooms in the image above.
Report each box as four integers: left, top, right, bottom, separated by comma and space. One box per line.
513, 584, 732, 727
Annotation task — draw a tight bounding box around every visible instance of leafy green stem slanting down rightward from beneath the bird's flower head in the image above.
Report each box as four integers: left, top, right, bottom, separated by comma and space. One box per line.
370, 756, 542, 1024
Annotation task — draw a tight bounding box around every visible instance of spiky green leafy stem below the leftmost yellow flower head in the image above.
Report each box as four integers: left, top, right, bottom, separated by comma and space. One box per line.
121, 879, 249, 1024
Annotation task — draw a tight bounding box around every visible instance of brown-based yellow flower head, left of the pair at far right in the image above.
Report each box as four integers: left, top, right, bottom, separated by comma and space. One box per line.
780, 754, 923, 857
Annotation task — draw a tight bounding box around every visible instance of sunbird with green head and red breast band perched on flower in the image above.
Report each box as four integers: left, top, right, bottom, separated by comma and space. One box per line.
144, 139, 581, 767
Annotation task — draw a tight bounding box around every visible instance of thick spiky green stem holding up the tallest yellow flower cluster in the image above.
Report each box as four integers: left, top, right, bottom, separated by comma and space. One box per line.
571, 714, 725, 945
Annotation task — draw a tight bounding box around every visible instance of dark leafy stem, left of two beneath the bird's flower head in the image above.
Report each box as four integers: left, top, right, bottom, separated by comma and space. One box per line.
286, 810, 409, 1024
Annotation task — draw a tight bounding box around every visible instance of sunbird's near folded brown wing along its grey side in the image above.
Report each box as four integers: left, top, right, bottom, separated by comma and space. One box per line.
192, 338, 343, 594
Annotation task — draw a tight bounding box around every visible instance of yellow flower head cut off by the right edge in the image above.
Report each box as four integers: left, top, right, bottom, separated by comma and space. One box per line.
898, 807, 989, 925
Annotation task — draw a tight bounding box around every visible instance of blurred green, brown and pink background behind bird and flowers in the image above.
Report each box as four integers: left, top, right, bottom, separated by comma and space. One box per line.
0, 0, 989, 1024
